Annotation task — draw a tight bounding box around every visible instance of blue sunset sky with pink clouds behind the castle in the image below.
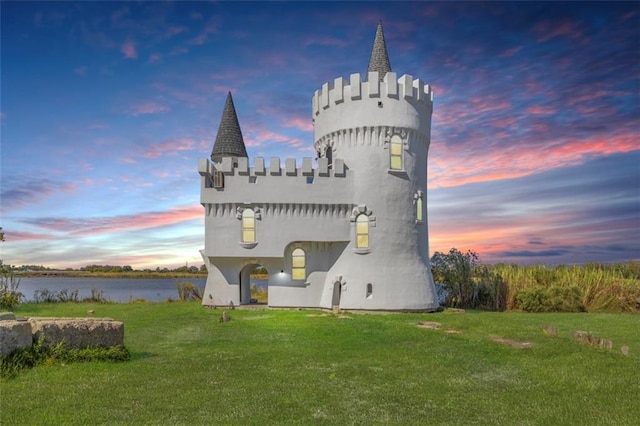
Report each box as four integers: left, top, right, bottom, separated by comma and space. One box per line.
0, 1, 640, 269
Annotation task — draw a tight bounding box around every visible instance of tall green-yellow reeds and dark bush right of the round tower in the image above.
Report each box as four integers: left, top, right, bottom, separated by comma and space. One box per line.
431, 248, 640, 313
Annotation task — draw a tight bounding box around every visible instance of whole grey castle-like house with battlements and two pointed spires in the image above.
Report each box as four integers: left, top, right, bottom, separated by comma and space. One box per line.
198, 25, 438, 311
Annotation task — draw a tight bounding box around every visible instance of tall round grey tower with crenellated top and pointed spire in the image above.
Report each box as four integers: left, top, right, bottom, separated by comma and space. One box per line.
312, 24, 438, 311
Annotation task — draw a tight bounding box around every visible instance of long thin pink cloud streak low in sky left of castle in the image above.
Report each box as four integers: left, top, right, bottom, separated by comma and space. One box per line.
21, 205, 203, 236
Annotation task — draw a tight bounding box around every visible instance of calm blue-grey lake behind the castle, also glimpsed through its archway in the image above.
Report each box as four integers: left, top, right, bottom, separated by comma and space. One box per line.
13, 277, 266, 303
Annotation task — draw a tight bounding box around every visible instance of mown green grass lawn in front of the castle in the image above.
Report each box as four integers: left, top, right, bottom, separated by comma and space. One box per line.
0, 302, 640, 425
